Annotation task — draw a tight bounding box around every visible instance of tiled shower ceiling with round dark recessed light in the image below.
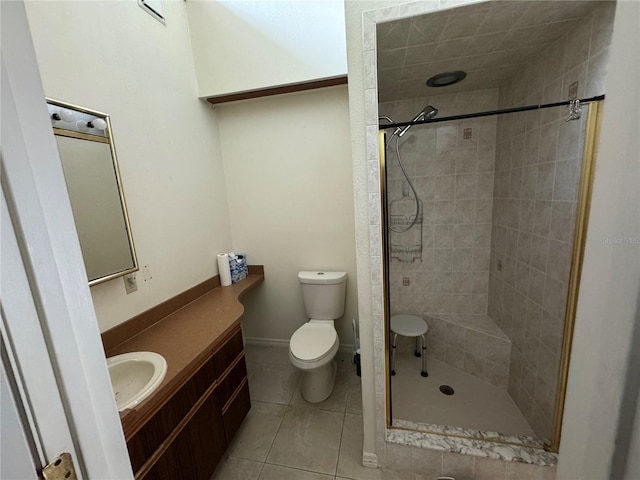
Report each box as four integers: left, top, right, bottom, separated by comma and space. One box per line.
377, 0, 602, 102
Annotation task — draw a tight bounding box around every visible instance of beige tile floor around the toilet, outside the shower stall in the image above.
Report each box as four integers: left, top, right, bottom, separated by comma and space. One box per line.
212, 345, 376, 480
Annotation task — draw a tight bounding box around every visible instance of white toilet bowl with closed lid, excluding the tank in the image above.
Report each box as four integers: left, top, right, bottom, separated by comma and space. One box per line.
289, 320, 339, 403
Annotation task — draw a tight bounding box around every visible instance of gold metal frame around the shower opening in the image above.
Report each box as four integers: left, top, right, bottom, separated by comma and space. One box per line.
378, 100, 603, 453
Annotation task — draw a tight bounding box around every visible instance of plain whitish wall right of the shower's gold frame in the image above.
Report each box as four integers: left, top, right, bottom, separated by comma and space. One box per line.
558, 1, 640, 479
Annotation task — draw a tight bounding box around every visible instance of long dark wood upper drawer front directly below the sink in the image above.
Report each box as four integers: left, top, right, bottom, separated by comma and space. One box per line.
127, 358, 216, 473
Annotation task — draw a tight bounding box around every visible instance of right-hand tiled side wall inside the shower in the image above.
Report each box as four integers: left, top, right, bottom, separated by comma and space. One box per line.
488, 3, 615, 438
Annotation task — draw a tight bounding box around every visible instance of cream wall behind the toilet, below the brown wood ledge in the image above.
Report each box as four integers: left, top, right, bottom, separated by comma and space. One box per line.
216, 86, 357, 344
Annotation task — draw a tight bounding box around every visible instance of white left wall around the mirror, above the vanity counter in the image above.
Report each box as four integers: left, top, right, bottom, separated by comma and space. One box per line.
26, 1, 231, 331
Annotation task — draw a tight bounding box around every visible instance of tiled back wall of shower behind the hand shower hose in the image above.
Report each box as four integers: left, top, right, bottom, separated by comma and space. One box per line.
379, 89, 498, 322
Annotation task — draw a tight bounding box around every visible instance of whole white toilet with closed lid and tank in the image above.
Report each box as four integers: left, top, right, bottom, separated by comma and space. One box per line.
289, 271, 347, 403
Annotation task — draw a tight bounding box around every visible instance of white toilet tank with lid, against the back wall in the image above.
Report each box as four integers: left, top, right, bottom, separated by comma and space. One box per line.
298, 271, 347, 320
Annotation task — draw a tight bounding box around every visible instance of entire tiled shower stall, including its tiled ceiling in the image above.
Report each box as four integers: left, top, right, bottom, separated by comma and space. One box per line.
375, 1, 615, 454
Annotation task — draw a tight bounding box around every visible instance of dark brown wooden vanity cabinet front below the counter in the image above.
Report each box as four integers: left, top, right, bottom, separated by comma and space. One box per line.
127, 327, 251, 480
